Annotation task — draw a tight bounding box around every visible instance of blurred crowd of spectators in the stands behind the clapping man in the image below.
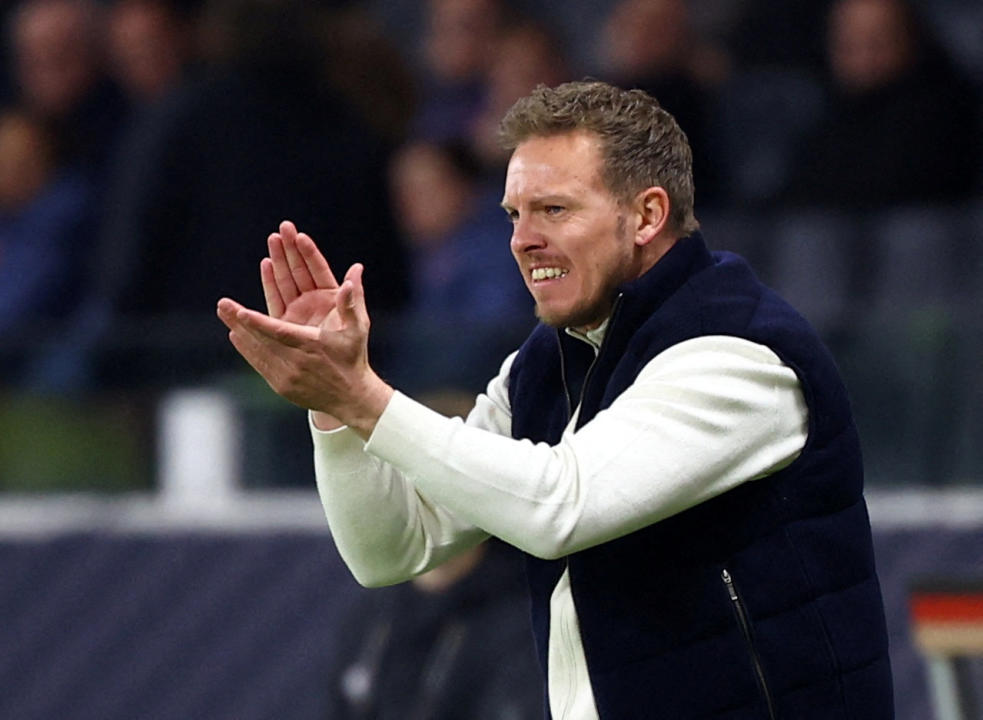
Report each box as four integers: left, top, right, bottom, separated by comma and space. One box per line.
0, 0, 983, 490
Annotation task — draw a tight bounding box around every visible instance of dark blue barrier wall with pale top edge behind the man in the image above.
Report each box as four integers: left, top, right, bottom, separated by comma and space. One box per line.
0, 492, 983, 720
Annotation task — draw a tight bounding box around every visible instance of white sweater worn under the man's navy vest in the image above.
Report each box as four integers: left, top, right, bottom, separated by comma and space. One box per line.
311, 333, 808, 720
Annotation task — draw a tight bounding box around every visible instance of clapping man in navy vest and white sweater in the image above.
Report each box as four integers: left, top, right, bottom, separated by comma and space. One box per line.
219, 82, 893, 720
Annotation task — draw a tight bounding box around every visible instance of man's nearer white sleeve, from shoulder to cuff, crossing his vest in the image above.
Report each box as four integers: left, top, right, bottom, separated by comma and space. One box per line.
364, 336, 808, 558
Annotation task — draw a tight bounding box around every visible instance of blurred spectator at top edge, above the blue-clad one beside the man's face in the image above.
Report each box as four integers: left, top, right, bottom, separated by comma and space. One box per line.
413, 0, 504, 140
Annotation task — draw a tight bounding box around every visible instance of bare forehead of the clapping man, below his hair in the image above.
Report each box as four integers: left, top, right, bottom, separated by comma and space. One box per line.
505, 131, 604, 202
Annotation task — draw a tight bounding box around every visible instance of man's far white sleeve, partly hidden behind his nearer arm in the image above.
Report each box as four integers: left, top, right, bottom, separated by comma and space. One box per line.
309, 353, 515, 586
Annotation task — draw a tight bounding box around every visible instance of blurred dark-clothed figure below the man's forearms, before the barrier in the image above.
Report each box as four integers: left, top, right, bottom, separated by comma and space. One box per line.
326, 541, 543, 720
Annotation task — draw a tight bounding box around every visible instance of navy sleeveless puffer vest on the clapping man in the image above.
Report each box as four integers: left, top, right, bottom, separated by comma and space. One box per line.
509, 233, 894, 720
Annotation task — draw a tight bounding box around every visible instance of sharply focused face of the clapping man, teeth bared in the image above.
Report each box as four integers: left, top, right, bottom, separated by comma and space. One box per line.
502, 131, 639, 329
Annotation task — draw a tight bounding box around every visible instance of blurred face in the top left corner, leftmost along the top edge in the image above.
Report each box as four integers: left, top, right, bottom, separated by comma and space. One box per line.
13, 0, 96, 116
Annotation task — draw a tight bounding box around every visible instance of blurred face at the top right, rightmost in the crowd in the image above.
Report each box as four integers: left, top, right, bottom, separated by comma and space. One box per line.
829, 0, 913, 91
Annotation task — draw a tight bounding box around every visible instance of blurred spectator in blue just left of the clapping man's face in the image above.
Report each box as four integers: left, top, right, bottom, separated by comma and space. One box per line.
390, 140, 531, 391
